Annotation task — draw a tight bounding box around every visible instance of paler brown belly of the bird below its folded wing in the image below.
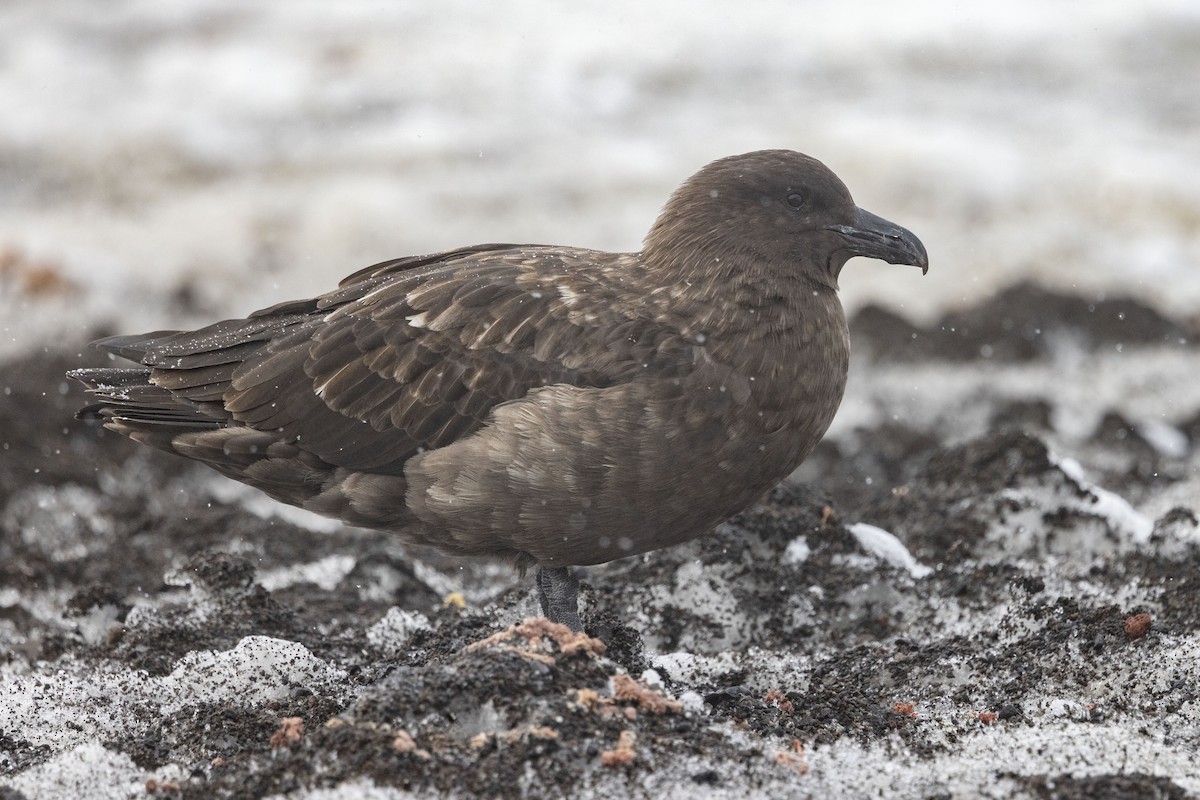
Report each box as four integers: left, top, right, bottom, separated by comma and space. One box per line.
406, 367, 840, 565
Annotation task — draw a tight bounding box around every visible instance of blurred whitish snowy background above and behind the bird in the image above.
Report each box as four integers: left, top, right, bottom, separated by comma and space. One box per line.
0, 0, 1200, 354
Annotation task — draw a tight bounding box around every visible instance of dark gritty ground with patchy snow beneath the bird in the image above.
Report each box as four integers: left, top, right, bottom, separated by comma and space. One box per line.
0, 284, 1200, 799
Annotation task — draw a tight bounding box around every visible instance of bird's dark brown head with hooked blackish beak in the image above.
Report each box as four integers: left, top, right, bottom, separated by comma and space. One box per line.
643, 150, 929, 288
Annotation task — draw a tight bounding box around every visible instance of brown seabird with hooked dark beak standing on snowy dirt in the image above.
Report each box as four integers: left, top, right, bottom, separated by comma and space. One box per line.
68, 150, 929, 632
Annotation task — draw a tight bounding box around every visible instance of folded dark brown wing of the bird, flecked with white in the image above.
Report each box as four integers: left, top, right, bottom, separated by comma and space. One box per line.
108, 245, 694, 473
